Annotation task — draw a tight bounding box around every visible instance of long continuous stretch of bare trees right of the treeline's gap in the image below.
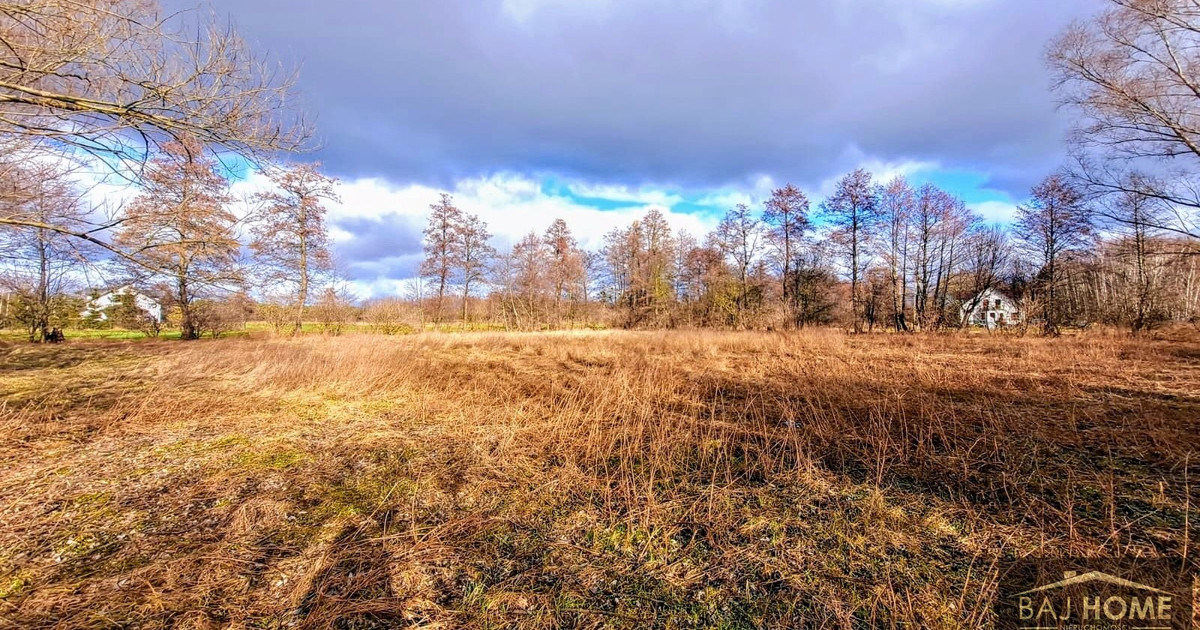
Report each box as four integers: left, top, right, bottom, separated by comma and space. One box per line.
396, 170, 1200, 334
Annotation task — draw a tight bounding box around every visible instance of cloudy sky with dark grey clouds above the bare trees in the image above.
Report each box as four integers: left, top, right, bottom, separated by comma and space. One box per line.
166, 0, 1096, 296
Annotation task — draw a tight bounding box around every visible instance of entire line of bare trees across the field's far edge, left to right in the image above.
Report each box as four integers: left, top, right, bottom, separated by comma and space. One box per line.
9, 147, 1200, 340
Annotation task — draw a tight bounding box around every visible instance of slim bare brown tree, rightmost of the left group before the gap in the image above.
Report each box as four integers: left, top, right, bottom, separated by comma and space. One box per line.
251, 164, 340, 334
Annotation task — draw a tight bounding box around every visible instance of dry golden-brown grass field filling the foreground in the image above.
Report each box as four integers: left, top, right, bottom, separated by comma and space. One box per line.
0, 331, 1200, 629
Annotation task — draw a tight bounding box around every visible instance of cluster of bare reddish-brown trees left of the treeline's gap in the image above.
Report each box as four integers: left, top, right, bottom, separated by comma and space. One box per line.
0, 136, 337, 341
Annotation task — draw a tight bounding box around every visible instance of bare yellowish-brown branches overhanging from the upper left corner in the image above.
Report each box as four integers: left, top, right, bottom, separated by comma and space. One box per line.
0, 0, 311, 258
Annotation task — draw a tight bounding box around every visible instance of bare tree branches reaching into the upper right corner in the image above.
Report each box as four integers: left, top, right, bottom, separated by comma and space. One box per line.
1048, 0, 1200, 238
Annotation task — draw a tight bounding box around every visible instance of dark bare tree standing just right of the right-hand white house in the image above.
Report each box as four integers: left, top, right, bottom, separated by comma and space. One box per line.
1016, 175, 1091, 335
